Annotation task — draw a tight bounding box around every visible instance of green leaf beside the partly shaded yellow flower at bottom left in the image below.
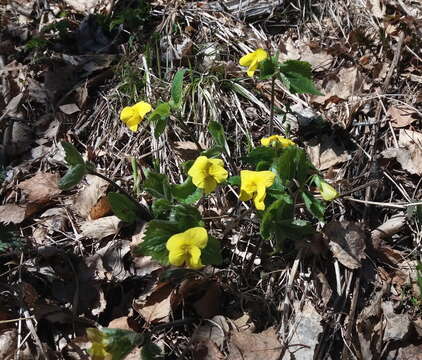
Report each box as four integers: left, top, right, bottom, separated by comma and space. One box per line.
101, 328, 144, 360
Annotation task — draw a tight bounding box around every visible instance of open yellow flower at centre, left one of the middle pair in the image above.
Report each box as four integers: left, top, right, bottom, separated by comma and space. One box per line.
188, 156, 228, 194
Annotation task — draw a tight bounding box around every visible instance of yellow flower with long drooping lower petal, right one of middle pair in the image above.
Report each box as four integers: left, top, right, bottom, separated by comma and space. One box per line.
239, 170, 275, 210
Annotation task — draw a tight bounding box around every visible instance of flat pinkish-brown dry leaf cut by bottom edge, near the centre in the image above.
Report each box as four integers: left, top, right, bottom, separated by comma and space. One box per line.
228, 328, 282, 360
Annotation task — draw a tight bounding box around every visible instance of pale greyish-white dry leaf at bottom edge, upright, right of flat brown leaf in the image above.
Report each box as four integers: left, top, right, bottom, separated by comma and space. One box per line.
289, 302, 323, 360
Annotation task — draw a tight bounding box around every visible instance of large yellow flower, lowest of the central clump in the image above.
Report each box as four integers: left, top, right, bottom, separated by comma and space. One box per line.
166, 227, 208, 269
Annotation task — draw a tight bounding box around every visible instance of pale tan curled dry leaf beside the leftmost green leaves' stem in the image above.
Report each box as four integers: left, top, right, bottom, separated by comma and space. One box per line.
73, 175, 109, 220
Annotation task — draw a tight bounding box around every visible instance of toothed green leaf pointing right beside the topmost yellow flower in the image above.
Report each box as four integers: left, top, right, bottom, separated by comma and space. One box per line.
280, 60, 322, 95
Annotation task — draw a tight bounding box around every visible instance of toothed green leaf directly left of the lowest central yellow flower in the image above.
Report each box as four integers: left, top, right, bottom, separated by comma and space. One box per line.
134, 220, 182, 265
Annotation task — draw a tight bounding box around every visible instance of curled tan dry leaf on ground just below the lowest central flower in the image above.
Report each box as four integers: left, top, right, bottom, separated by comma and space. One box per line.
133, 282, 173, 323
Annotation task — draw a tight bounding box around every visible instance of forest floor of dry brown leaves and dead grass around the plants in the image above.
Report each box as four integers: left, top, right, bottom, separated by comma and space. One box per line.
0, 0, 422, 360
